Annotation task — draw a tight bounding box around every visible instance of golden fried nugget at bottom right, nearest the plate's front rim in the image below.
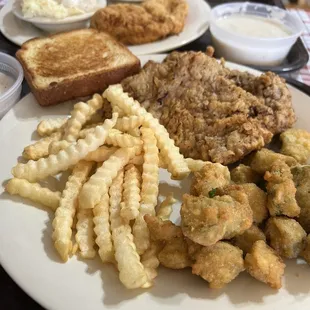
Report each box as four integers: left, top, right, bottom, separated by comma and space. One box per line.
245, 240, 285, 289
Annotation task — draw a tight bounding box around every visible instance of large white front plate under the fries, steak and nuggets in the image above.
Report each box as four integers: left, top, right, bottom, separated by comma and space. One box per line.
0, 55, 310, 310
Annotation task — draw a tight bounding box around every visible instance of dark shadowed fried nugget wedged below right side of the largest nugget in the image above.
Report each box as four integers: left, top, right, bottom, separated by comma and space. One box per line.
233, 225, 266, 254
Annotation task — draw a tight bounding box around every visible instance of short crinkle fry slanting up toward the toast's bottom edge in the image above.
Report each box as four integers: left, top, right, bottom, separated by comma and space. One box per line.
64, 94, 103, 142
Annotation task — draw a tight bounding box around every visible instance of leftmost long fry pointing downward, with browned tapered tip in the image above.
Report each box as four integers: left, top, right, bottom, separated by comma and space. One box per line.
52, 161, 93, 262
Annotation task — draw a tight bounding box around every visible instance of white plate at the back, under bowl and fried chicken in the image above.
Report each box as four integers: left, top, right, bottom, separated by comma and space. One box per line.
0, 0, 210, 55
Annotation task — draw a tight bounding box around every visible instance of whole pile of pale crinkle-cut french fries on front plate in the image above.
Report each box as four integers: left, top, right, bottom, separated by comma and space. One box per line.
6, 85, 205, 289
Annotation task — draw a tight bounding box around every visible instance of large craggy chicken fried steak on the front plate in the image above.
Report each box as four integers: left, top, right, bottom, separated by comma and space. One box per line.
122, 52, 295, 164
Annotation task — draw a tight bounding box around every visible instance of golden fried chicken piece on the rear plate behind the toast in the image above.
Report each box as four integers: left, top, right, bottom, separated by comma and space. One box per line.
91, 0, 188, 45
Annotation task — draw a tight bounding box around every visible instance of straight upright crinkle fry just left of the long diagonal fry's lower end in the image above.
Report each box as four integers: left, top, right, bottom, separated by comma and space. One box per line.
141, 127, 159, 208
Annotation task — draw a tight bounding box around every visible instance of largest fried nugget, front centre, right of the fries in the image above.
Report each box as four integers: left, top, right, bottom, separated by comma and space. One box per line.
180, 185, 253, 246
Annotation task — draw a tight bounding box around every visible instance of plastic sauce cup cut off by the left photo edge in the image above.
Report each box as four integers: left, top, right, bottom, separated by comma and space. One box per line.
0, 52, 24, 119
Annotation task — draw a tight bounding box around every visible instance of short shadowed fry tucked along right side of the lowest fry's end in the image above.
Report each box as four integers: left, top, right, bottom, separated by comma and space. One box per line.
141, 242, 161, 288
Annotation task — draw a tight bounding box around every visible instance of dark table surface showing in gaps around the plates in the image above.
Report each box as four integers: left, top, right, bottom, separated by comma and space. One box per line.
0, 0, 308, 310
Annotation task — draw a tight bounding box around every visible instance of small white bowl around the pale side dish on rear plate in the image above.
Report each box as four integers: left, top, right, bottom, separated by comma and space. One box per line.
12, 0, 107, 33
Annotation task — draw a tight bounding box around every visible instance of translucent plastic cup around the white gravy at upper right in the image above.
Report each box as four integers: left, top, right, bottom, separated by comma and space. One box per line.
210, 2, 304, 66
